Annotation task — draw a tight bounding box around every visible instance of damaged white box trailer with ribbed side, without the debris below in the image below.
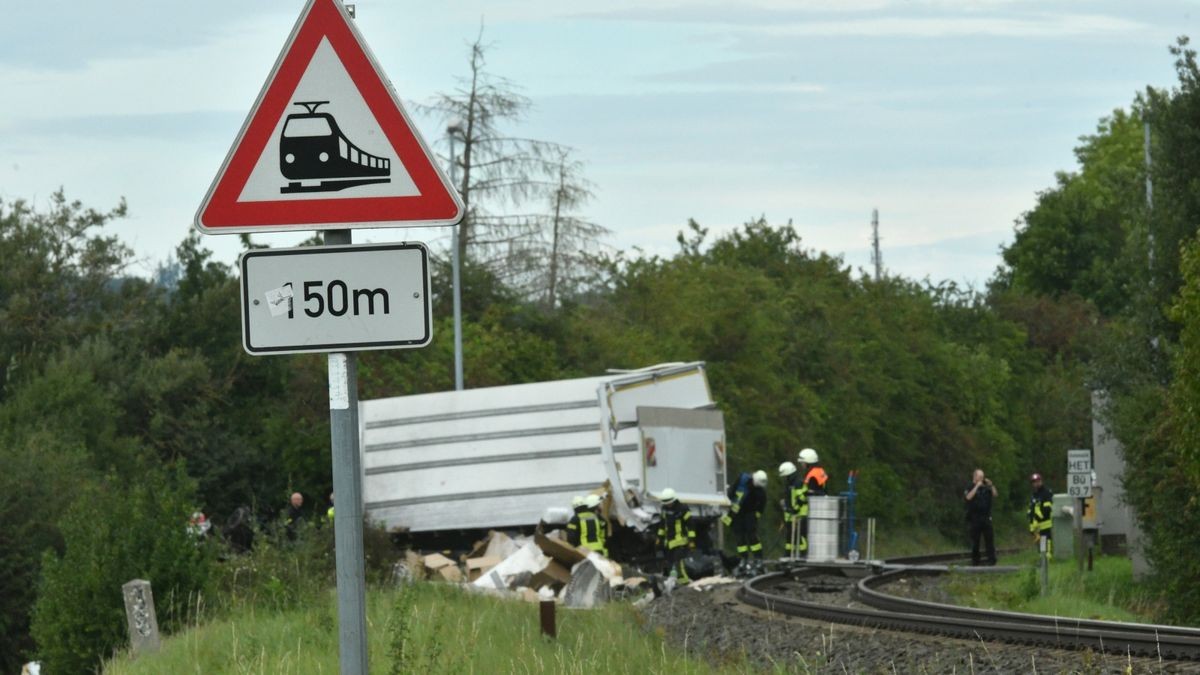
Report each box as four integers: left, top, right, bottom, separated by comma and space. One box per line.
359, 363, 728, 532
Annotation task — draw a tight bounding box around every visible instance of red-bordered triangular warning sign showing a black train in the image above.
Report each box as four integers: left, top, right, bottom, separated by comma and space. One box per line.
196, 0, 462, 234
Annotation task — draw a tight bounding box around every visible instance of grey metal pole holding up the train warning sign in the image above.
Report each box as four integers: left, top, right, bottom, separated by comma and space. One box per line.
325, 229, 367, 675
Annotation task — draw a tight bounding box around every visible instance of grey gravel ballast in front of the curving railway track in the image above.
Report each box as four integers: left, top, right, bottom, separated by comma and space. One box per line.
642, 584, 1200, 674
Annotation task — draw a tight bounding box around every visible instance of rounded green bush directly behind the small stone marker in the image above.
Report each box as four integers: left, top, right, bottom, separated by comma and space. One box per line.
31, 470, 210, 673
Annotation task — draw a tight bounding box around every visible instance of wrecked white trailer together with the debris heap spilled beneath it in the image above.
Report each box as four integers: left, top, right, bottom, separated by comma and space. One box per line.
359, 362, 730, 595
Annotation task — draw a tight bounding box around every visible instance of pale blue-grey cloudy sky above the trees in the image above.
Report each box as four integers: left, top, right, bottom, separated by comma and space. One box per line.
0, 0, 1198, 286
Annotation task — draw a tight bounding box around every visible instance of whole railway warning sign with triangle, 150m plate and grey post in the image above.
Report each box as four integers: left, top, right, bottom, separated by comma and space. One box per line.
194, 0, 463, 675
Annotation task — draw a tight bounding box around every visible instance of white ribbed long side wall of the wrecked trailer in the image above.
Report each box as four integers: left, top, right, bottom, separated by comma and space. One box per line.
360, 364, 712, 532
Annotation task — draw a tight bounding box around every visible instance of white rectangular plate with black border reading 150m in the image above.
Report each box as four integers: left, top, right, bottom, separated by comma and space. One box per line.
241, 243, 433, 354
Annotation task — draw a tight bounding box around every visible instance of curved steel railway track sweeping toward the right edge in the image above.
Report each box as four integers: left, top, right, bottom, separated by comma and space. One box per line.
738, 554, 1200, 661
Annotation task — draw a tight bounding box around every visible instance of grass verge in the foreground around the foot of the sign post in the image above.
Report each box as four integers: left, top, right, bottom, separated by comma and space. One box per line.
104, 583, 714, 675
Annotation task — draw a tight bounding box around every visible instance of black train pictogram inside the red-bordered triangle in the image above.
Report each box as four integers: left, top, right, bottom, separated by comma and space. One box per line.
280, 101, 391, 193
